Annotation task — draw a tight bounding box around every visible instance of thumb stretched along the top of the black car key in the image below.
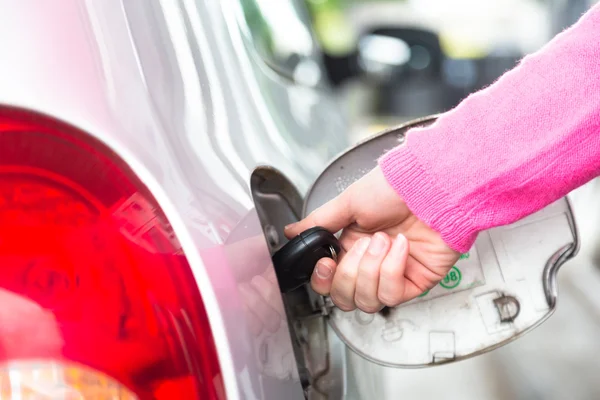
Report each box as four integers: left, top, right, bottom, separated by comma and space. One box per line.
284, 190, 354, 239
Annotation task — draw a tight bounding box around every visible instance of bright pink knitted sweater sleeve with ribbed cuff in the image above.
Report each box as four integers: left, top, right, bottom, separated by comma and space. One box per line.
379, 5, 600, 252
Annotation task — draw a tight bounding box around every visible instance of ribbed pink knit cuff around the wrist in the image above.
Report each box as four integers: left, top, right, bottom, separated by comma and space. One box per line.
379, 144, 478, 253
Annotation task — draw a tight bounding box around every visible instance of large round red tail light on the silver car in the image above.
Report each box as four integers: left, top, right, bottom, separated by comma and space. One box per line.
0, 110, 224, 400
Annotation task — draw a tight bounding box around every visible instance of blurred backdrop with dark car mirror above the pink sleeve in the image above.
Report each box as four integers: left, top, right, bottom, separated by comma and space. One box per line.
306, 0, 594, 141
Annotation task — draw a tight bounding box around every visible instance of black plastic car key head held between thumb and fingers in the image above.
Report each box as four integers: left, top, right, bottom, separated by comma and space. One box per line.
272, 226, 341, 293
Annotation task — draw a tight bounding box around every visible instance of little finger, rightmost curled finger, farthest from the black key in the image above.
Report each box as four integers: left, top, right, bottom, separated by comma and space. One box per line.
377, 234, 408, 307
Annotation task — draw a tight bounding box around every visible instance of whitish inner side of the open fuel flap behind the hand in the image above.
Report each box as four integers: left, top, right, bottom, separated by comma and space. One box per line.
302, 117, 578, 367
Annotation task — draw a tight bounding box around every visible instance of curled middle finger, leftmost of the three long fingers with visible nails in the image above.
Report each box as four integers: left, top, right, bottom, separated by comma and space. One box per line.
331, 237, 371, 311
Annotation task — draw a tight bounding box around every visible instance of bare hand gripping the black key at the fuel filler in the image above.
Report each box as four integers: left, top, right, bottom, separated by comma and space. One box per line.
285, 167, 460, 313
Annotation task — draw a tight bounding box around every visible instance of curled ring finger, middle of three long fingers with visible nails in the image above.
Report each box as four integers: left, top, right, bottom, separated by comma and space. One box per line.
354, 232, 391, 313
